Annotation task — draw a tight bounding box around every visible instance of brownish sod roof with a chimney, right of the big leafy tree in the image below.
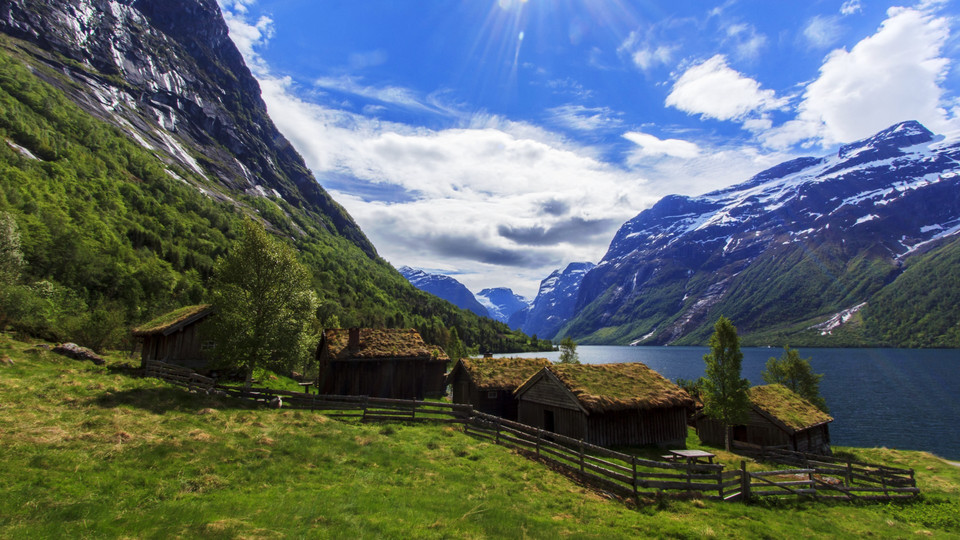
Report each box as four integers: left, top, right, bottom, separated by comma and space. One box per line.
324, 328, 450, 361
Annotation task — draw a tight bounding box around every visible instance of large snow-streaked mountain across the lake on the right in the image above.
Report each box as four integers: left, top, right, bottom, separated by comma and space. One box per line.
565, 121, 960, 343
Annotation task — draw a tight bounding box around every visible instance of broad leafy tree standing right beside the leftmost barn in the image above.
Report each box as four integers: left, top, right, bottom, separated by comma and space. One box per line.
211, 220, 317, 386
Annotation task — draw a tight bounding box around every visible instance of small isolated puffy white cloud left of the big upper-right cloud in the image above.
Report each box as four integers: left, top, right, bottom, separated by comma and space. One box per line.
666, 54, 785, 120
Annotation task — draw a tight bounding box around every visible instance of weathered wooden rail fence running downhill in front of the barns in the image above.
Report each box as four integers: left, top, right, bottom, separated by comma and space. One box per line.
144, 361, 919, 502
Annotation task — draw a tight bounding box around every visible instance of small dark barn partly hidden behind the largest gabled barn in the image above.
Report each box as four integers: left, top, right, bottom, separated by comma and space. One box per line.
447, 358, 550, 420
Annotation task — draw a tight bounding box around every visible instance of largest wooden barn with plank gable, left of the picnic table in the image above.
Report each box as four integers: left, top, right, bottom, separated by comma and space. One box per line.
515, 362, 693, 447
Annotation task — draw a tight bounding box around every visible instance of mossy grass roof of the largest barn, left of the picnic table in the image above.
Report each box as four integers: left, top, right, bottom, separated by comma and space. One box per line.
549, 362, 693, 412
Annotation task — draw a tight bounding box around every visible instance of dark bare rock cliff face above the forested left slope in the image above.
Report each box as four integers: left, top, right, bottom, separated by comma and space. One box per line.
0, 0, 376, 257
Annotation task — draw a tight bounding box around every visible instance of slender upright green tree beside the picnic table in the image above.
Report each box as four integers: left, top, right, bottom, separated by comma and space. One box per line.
703, 316, 750, 451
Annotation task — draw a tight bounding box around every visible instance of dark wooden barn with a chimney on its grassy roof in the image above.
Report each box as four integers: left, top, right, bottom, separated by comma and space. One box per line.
316, 328, 450, 399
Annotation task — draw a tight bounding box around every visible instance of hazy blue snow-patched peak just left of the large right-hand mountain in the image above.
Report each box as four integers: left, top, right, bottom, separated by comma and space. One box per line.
507, 262, 594, 339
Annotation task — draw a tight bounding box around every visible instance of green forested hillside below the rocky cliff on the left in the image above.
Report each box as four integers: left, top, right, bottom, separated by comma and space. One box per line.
0, 42, 544, 351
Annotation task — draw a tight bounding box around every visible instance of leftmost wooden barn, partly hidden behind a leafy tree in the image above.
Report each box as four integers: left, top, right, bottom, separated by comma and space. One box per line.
133, 304, 213, 370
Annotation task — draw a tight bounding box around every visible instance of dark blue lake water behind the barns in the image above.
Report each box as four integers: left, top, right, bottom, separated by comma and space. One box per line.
499, 345, 960, 460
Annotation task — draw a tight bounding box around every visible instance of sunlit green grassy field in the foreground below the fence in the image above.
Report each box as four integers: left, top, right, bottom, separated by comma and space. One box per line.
0, 335, 960, 538
